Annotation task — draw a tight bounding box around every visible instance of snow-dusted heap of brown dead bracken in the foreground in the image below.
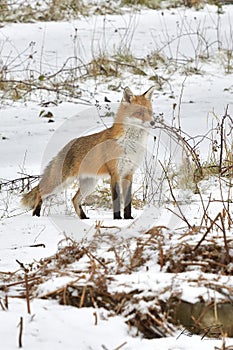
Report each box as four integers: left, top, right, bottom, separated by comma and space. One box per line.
0, 215, 233, 339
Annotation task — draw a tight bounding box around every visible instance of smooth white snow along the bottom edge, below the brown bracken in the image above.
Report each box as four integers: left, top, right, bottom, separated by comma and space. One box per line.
0, 300, 226, 350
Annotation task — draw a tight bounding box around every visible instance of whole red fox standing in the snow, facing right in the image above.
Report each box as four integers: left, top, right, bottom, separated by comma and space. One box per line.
22, 87, 154, 219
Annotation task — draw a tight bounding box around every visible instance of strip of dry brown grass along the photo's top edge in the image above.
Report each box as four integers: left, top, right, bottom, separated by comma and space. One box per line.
0, 0, 228, 23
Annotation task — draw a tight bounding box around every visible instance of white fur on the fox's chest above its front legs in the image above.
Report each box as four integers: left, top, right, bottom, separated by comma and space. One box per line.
118, 126, 148, 176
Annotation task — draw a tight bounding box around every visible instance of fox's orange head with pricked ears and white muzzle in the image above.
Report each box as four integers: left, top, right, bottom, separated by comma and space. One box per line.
118, 86, 155, 126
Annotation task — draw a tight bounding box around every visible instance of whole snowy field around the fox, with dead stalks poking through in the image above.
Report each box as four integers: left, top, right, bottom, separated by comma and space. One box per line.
0, 5, 233, 350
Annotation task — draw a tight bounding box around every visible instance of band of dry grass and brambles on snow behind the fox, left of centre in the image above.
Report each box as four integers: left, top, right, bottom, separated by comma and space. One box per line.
0, 48, 164, 105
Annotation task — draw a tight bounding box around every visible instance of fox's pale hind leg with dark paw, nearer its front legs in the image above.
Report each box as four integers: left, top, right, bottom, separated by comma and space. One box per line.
72, 177, 98, 219
